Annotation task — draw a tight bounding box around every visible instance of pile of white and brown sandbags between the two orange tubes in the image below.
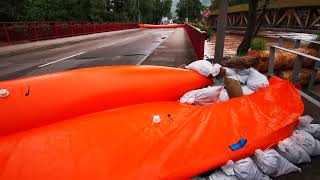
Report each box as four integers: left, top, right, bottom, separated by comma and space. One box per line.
180, 60, 269, 106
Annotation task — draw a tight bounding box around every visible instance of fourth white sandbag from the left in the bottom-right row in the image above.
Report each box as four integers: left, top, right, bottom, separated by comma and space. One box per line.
276, 137, 311, 164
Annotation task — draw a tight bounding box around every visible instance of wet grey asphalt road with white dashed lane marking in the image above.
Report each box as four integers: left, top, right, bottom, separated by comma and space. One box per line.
0, 29, 174, 80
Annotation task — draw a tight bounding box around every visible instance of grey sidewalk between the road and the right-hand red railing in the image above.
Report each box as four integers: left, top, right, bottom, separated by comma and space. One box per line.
142, 28, 196, 67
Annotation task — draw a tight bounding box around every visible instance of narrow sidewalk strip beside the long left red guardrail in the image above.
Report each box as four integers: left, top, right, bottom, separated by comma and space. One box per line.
0, 29, 140, 56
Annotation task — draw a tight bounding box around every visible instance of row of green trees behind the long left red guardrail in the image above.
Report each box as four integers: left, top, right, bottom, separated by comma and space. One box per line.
0, 0, 172, 23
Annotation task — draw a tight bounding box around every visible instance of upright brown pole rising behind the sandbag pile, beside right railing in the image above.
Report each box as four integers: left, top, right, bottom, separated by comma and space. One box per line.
214, 0, 228, 63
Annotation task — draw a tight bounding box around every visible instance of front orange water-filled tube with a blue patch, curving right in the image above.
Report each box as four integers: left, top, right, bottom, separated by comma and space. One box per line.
0, 76, 303, 180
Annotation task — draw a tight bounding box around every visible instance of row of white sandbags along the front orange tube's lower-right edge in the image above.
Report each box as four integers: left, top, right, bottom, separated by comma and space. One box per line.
192, 116, 320, 180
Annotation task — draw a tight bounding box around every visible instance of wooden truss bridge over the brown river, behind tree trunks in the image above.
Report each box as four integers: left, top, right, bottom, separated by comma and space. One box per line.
208, 0, 320, 32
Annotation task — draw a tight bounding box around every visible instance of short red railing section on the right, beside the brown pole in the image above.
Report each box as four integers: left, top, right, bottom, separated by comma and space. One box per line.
185, 24, 207, 59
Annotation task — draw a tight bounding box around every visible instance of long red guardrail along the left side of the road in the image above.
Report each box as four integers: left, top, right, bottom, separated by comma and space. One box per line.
0, 22, 138, 45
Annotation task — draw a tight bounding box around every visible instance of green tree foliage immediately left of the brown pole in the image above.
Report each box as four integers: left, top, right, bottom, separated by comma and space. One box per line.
176, 0, 204, 21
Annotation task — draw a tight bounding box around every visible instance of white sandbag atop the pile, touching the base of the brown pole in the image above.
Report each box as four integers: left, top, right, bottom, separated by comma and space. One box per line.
186, 60, 221, 77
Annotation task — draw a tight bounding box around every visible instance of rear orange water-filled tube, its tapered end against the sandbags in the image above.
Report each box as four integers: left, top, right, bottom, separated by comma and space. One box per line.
0, 66, 211, 135
